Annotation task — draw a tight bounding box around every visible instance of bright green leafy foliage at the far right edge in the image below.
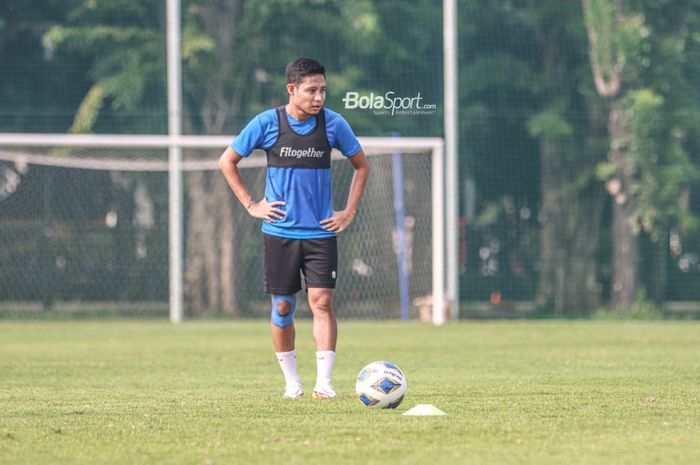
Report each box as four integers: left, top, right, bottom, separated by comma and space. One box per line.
586, 0, 700, 250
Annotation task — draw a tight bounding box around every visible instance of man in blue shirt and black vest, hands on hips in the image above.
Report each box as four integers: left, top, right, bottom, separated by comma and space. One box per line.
219, 58, 369, 399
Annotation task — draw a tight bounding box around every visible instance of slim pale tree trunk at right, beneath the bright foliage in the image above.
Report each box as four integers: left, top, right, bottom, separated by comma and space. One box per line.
608, 100, 639, 308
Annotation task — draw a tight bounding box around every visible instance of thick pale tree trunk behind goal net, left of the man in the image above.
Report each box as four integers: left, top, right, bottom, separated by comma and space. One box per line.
185, 0, 245, 317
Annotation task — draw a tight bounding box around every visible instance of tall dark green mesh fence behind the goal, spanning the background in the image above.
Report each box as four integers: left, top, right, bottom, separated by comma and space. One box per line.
0, 0, 700, 316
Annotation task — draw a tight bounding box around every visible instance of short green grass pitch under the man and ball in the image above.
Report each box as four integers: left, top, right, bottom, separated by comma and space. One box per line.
0, 321, 700, 465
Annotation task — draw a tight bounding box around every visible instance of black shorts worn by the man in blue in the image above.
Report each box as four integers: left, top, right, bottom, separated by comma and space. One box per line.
263, 233, 338, 294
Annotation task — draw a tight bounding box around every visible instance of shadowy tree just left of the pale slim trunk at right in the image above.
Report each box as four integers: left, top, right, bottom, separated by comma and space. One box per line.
528, 1, 604, 315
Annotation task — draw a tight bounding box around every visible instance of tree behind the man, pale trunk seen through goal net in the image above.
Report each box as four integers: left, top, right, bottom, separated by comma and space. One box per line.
183, 0, 437, 315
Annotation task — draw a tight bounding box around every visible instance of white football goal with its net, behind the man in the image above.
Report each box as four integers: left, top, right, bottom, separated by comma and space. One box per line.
0, 135, 443, 319
